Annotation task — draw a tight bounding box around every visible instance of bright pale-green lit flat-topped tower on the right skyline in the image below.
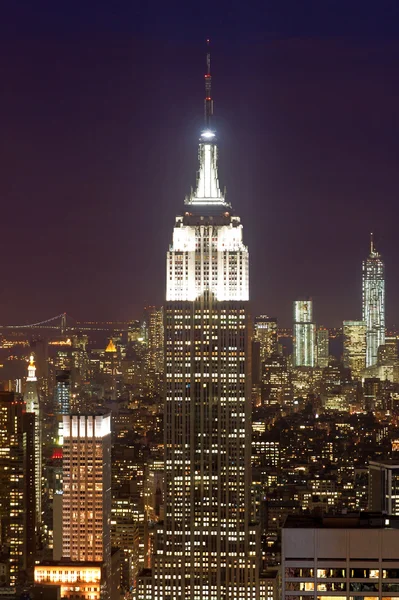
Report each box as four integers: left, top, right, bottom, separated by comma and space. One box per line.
293, 300, 316, 367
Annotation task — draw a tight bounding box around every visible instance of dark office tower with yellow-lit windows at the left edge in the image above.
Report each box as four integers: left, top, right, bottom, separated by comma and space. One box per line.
0, 392, 36, 587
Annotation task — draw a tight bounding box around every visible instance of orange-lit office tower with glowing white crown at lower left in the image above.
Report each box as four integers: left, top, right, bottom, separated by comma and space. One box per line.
62, 414, 111, 592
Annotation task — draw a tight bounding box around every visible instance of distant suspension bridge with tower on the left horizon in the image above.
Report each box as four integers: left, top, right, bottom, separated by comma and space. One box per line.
0, 313, 129, 335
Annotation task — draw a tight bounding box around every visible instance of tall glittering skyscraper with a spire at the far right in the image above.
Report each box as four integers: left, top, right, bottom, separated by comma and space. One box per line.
362, 234, 385, 367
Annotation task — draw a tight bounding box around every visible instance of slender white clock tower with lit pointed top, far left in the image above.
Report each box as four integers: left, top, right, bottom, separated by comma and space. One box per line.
24, 354, 42, 527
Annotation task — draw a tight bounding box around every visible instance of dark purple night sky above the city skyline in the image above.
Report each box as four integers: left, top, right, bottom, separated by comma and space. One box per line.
0, 0, 399, 326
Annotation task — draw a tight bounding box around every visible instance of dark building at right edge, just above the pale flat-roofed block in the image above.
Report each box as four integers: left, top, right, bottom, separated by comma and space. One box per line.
369, 460, 399, 516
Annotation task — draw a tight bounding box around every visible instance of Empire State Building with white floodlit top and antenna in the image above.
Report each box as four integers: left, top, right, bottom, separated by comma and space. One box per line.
152, 48, 259, 600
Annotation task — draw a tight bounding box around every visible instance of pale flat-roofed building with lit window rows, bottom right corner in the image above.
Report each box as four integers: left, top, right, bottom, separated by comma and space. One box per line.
281, 513, 399, 600
